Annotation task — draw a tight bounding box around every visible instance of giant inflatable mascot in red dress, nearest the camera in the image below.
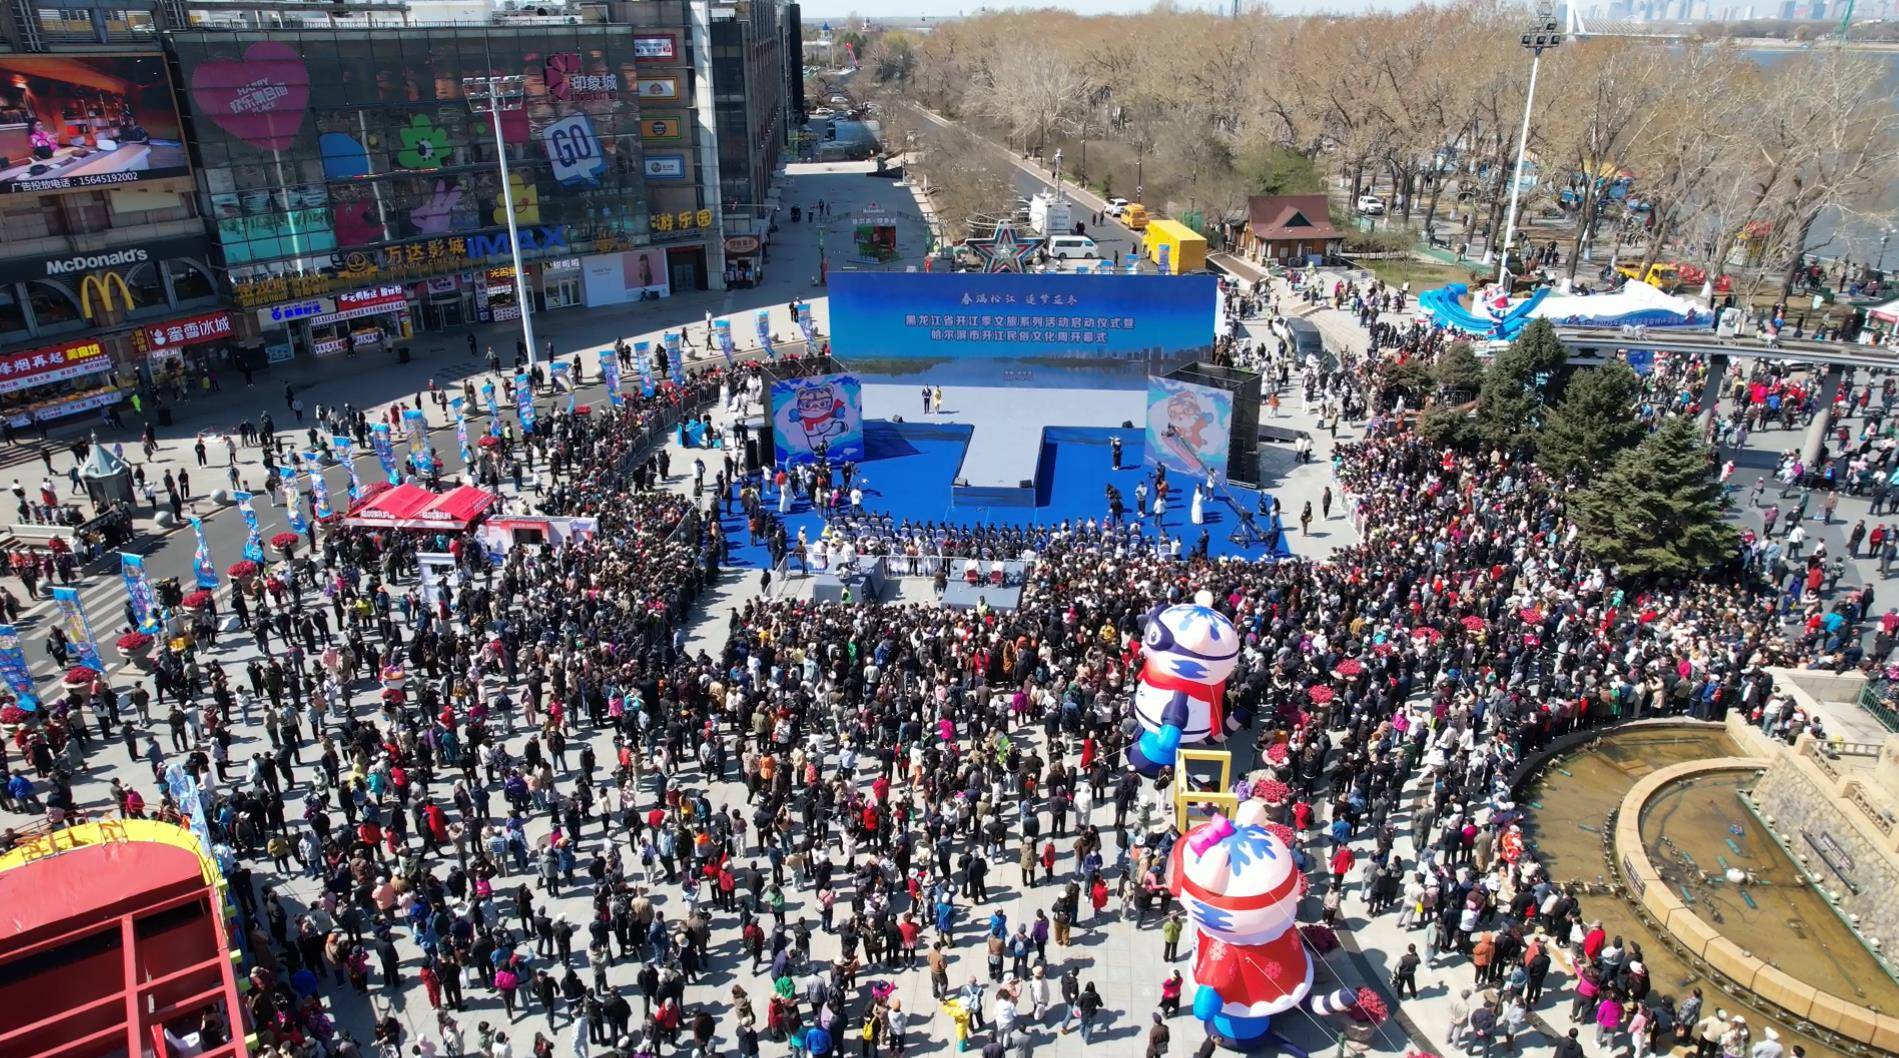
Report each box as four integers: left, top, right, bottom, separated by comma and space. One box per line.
1168, 800, 1312, 1050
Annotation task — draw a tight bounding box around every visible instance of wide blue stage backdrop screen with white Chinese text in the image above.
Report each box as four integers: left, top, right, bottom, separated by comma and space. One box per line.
830, 272, 1219, 386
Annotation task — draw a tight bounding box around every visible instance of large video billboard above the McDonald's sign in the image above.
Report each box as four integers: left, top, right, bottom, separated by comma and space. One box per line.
0, 55, 190, 194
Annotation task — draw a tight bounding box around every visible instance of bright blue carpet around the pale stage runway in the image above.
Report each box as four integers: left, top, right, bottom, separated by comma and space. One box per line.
724, 420, 1289, 570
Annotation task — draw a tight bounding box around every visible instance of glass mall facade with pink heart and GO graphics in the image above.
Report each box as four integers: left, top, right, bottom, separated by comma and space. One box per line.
171, 25, 653, 308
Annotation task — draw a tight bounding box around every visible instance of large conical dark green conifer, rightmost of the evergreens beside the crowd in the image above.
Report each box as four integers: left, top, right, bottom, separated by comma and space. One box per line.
1570, 416, 1736, 577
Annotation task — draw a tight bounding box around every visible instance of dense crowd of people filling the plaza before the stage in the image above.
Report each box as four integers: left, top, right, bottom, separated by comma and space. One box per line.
0, 267, 1871, 1058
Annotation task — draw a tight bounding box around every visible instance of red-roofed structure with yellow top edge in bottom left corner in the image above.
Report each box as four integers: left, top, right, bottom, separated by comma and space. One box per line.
0, 821, 249, 1058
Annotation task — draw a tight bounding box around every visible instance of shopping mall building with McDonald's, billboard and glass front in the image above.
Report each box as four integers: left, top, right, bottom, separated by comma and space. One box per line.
0, 0, 799, 425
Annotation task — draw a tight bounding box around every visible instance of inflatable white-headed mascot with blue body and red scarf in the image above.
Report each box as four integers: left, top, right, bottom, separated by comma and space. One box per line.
1128, 591, 1240, 777
